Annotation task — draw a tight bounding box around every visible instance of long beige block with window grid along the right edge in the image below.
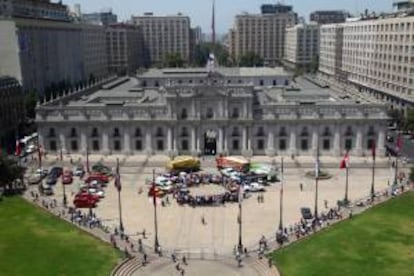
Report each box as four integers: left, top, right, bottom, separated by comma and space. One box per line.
319, 14, 414, 109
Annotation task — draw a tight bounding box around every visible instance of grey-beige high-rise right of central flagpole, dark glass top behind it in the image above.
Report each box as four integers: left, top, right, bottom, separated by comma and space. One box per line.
229, 4, 297, 65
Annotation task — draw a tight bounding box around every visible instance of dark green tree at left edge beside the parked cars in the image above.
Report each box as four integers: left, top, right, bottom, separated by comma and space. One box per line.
0, 155, 25, 190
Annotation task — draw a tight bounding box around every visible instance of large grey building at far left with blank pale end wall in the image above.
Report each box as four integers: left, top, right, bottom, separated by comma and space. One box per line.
0, 18, 107, 94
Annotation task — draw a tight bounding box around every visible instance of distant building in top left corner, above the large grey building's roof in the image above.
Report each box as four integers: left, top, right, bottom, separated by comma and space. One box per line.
0, 0, 70, 21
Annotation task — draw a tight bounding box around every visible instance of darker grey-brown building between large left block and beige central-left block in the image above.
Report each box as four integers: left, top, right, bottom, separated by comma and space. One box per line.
106, 23, 145, 75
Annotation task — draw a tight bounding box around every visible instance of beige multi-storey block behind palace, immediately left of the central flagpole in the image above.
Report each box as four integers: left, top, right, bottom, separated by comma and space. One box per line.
132, 13, 191, 63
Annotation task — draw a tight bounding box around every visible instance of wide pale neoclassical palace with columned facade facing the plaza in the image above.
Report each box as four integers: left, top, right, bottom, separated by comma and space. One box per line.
36, 64, 387, 156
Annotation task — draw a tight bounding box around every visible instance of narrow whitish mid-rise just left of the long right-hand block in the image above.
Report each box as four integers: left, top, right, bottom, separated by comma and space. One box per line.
284, 23, 319, 70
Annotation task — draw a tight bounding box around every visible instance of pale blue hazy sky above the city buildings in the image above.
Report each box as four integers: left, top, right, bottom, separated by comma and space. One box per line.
63, 0, 393, 33
